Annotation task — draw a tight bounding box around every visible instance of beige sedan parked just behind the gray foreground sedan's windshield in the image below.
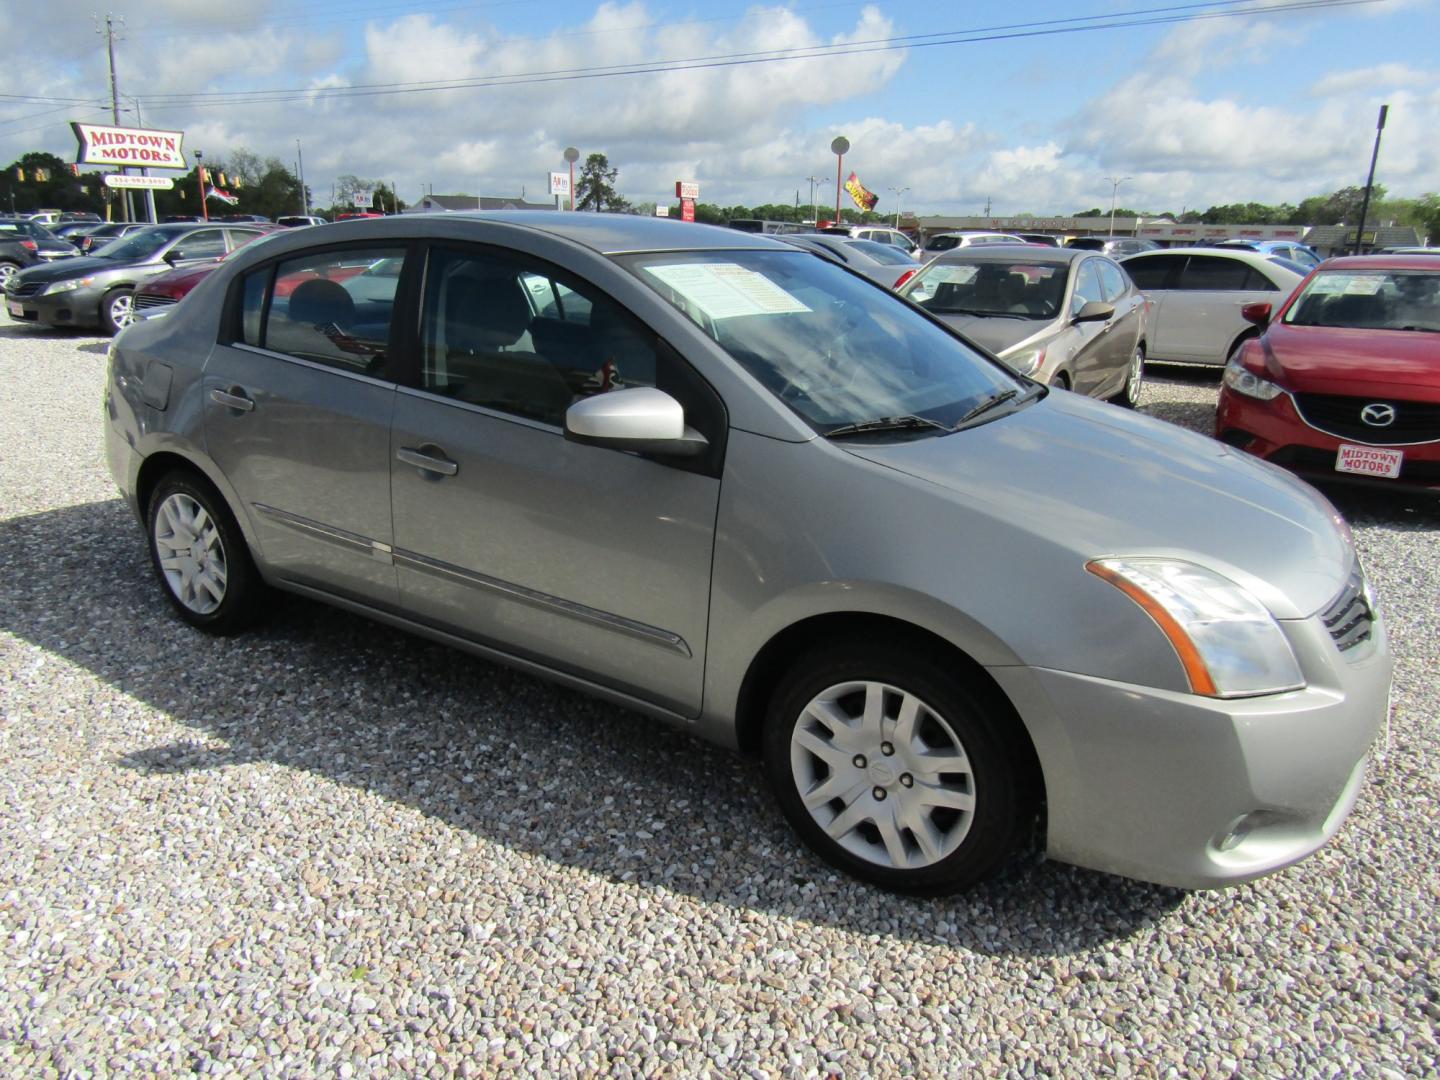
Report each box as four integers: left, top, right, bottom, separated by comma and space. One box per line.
900, 245, 1146, 409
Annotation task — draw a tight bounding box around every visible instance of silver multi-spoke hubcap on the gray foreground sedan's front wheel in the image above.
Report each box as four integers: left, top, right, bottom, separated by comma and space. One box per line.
791, 681, 975, 870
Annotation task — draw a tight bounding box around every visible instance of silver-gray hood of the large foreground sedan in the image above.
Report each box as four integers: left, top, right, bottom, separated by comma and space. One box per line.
841, 392, 1354, 619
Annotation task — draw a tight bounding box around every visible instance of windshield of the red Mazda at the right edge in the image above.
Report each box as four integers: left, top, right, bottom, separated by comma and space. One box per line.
1284, 269, 1440, 333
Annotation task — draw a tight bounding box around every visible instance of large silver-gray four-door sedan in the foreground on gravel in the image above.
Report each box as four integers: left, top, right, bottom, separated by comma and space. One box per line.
104, 212, 1391, 893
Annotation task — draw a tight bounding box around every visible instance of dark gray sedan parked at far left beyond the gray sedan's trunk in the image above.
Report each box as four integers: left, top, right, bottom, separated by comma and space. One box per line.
4, 225, 262, 334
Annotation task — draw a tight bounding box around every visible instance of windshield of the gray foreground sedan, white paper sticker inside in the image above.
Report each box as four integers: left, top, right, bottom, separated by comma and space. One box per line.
625, 251, 1027, 438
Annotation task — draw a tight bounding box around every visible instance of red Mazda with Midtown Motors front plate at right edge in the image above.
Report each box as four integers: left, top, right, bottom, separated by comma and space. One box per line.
1215, 255, 1440, 491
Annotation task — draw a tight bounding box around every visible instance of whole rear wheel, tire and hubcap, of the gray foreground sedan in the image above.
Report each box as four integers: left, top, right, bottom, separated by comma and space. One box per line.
145, 469, 265, 635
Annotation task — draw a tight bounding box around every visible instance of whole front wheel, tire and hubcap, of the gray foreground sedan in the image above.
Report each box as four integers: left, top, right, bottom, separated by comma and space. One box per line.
763, 639, 1035, 896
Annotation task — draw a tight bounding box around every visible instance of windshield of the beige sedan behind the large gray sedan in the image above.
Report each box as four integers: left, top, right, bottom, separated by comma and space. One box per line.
903, 259, 1070, 320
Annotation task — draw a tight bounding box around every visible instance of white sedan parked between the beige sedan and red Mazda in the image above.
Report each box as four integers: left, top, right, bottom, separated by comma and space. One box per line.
1120, 248, 1305, 367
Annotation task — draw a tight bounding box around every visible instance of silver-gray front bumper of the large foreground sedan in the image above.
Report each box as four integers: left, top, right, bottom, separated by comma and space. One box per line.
991, 616, 1392, 888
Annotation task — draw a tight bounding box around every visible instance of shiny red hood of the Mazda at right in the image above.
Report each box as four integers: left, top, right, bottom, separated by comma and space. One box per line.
1261, 323, 1440, 402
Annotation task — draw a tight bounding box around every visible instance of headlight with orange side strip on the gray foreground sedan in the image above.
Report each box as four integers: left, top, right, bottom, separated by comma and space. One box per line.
1086, 559, 1305, 697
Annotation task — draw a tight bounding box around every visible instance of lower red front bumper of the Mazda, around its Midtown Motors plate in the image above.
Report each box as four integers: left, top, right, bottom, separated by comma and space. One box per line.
1215, 387, 1440, 491
